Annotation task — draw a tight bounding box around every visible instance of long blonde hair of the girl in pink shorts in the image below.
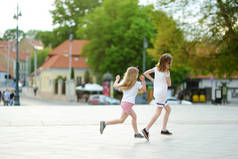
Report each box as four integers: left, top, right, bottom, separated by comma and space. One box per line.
118, 67, 139, 91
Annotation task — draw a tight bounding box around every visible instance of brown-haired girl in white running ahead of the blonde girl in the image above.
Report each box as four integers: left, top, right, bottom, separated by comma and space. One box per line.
142, 54, 172, 140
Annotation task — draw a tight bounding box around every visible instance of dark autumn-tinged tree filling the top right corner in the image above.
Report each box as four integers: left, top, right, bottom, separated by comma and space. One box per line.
158, 0, 238, 77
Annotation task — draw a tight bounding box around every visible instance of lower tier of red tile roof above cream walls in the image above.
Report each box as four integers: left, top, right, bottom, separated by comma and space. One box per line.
40, 55, 89, 69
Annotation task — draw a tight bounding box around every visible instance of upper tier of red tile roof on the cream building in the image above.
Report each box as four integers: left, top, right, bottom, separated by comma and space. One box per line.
48, 40, 89, 56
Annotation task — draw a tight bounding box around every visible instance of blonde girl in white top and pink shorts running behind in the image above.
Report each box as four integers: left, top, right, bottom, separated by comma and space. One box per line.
100, 67, 146, 138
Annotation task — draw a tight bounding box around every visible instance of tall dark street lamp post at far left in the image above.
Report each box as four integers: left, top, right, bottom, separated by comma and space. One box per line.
13, 4, 21, 105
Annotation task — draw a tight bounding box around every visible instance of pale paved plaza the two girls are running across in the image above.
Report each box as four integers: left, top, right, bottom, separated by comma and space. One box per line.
0, 96, 238, 159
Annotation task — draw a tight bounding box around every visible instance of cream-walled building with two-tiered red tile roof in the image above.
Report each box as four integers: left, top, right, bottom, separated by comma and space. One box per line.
32, 40, 94, 95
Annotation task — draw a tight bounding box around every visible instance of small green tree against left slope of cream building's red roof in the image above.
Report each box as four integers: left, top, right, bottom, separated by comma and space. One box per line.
31, 48, 51, 72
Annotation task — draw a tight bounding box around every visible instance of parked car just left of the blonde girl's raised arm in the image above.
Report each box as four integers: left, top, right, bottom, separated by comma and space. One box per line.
88, 94, 120, 105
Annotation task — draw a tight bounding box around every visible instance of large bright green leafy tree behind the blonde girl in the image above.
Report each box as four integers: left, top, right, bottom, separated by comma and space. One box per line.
77, 0, 155, 76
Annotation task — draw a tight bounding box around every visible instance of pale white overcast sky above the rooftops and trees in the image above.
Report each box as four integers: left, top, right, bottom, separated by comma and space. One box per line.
0, 0, 155, 37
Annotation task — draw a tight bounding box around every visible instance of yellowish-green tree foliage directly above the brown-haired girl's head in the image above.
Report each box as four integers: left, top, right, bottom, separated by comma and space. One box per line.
148, 11, 187, 66
